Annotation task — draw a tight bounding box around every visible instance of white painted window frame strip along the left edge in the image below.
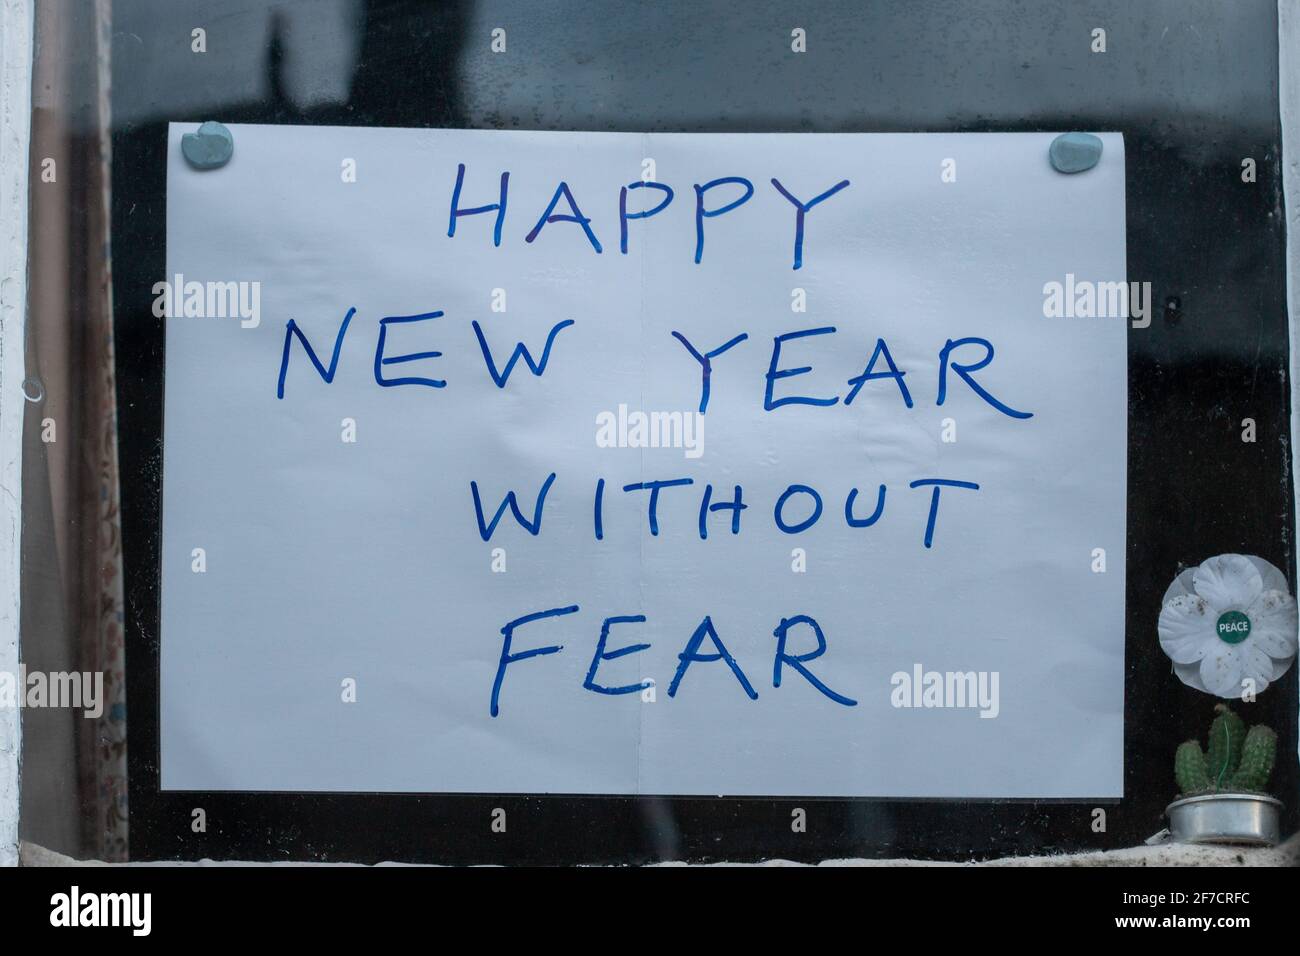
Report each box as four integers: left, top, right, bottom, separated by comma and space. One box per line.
0, 0, 34, 866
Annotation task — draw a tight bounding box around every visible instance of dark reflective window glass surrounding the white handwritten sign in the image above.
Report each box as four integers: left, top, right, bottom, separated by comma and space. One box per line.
113, 0, 1300, 862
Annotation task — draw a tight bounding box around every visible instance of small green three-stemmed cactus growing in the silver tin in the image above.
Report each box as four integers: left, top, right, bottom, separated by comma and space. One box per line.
1174, 704, 1278, 796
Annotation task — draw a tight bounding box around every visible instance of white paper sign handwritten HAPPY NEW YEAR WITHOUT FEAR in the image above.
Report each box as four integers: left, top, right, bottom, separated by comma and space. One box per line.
155, 126, 1128, 799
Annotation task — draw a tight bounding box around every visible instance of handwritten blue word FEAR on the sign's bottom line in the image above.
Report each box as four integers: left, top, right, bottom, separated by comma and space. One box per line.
489, 604, 858, 717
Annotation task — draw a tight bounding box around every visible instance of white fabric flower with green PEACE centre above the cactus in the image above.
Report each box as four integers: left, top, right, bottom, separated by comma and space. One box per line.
1158, 554, 1296, 698
